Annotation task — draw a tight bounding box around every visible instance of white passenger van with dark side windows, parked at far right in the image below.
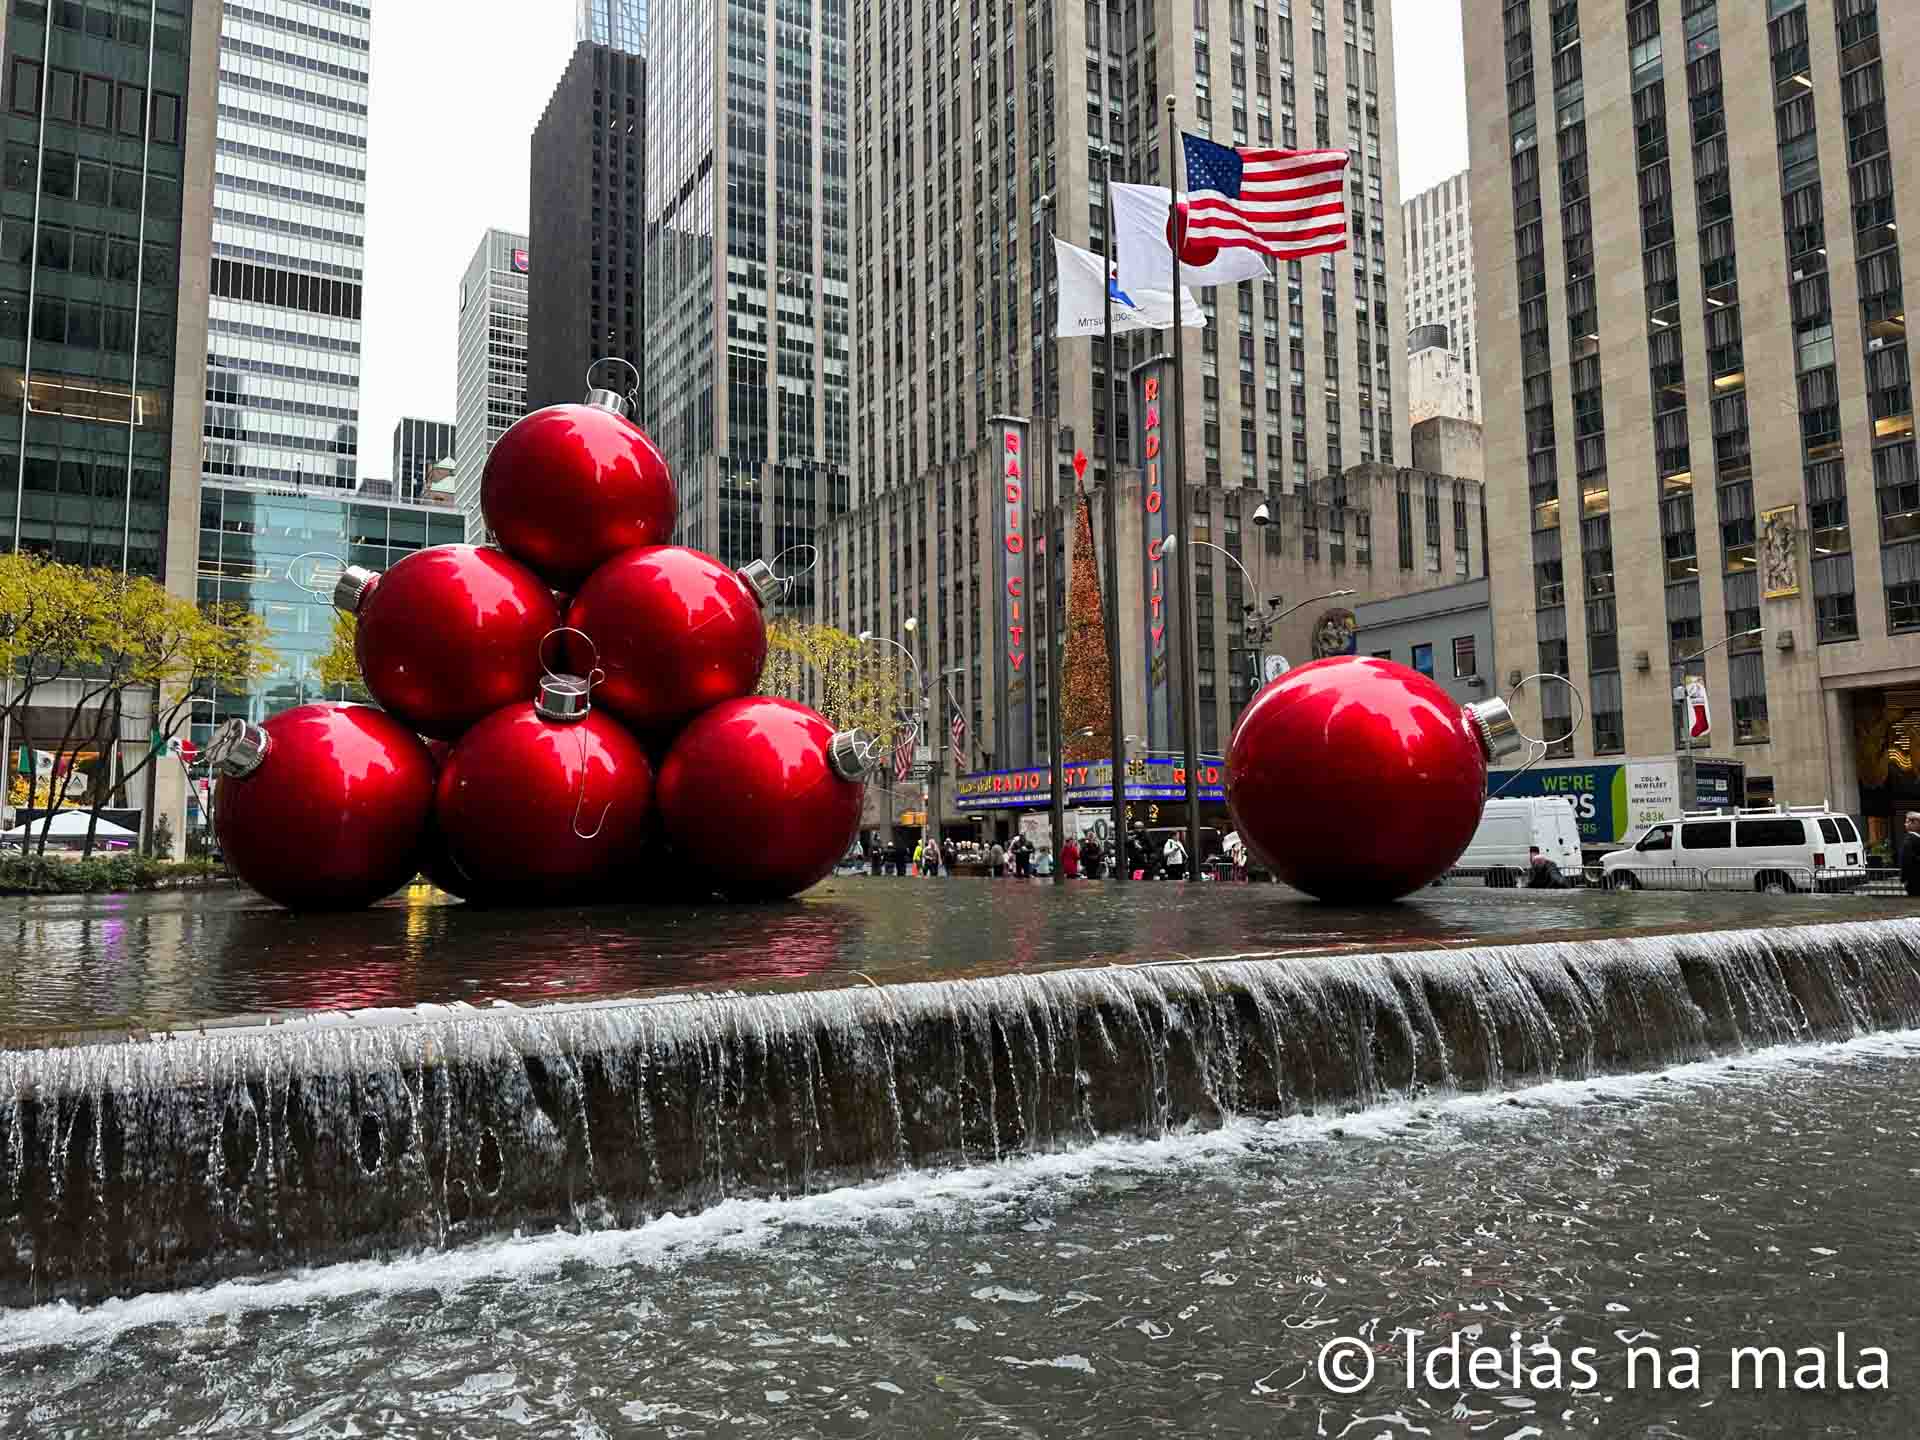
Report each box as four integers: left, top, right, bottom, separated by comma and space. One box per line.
1599, 804, 1866, 895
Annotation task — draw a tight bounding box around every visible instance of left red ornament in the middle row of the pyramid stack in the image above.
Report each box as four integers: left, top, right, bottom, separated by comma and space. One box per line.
334, 545, 561, 739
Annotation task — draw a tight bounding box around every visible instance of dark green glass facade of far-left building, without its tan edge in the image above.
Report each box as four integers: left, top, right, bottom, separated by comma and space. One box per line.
0, 0, 205, 580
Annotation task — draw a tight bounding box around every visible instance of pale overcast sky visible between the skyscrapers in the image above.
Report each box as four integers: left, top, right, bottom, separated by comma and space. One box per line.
359, 0, 1467, 476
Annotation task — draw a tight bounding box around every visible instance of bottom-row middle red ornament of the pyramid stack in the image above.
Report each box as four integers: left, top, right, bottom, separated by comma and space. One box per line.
434, 676, 653, 904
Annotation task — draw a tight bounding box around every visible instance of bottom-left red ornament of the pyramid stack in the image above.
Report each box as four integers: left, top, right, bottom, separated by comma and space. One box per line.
207, 705, 434, 910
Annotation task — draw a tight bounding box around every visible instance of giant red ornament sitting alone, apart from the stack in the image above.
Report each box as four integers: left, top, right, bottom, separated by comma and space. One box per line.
1227, 655, 1521, 900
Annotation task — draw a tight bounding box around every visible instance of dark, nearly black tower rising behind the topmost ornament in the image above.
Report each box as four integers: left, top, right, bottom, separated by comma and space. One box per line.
526, 42, 647, 409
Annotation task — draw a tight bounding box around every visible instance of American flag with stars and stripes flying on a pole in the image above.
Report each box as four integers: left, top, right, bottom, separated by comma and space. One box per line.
1183, 134, 1348, 259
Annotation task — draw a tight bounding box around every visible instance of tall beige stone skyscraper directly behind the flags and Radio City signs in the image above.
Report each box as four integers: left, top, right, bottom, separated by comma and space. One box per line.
817, 0, 1405, 806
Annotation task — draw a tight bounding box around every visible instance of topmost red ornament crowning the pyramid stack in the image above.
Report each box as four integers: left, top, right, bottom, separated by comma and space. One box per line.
480, 361, 680, 589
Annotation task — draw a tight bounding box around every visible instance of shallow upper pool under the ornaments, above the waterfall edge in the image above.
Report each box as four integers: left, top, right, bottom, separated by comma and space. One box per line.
0, 876, 1912, 1043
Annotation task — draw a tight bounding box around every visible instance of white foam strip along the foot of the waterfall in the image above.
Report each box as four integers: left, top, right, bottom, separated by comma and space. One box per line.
15, 1029, 1920, 1363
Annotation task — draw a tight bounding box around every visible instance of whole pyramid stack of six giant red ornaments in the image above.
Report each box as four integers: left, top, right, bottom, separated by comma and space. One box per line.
209, 372, 872, 910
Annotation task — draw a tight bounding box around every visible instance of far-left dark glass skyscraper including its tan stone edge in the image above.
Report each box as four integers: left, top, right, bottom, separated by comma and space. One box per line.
0, 0, 221, 845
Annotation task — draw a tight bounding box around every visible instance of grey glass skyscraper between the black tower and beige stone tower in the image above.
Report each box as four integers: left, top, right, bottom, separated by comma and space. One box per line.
643, 0, 851, 605
